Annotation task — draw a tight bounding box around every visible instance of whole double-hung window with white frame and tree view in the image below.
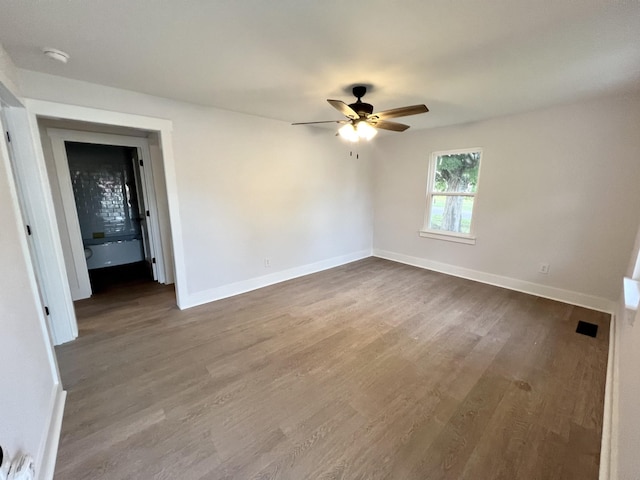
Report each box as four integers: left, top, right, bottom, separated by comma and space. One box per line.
420, 148, 482, 244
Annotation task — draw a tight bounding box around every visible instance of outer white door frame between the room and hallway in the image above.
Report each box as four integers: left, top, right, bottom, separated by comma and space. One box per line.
8, 99, 188, 345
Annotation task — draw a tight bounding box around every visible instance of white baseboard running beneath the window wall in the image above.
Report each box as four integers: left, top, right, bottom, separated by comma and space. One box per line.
373, 249, 616, 314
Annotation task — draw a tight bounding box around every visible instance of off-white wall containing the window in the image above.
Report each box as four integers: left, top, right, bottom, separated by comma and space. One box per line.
374, 95, 640, 310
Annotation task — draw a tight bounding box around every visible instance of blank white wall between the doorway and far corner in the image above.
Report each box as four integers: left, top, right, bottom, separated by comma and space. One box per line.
19, 70, 372, 304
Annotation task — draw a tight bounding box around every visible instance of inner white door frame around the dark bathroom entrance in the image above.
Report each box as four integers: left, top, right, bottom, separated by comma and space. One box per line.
47, 128, 167, 300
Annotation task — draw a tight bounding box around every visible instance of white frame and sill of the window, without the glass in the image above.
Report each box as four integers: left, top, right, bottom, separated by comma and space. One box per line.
419, 147, 484, 245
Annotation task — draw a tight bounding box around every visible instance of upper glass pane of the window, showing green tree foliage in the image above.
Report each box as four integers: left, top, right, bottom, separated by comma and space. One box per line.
433, 152, 480, 193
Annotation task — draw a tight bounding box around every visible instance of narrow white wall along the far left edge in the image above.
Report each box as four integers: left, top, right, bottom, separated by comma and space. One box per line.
0, 46, 59, 478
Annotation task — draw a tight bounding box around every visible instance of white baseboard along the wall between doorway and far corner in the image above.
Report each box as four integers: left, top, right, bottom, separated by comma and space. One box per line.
180, 250, 371, 309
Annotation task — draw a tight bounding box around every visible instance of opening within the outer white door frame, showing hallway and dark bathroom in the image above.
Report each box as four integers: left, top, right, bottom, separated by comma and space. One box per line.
41, 127, 170, 301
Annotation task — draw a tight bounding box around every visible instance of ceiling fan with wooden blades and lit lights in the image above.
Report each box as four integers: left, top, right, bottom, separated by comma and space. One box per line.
292, 85, 429, 142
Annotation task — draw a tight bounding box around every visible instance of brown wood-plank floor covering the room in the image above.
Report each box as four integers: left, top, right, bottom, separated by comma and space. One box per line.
55, 258, 609, 480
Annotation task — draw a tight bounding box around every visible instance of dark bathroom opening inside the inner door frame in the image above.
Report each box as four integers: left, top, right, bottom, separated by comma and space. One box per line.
65, 142, 157, 293
